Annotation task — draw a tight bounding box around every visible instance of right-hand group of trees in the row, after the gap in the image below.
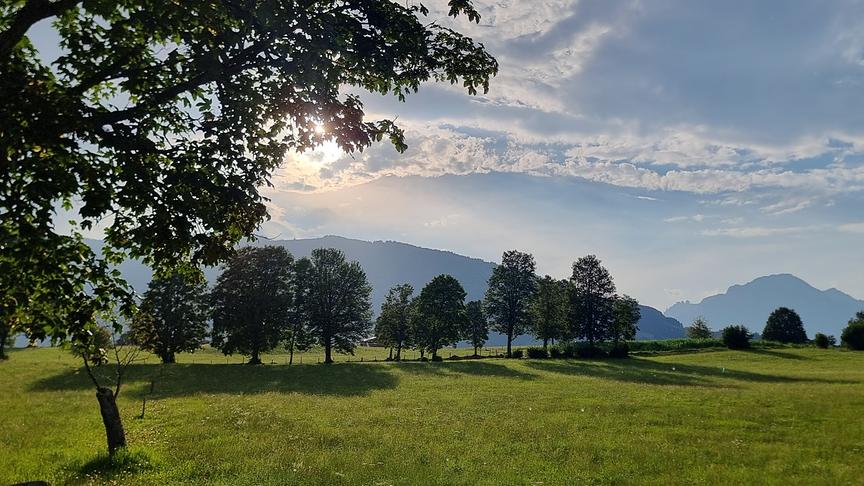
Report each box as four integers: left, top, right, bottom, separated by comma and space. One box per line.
375, 250, 641, 360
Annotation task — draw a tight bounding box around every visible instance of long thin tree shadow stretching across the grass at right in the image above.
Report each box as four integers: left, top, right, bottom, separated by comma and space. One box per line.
527, 358, 856, 388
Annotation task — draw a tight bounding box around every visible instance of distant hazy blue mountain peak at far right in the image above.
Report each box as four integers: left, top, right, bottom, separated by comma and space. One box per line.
666, 274, 864, 338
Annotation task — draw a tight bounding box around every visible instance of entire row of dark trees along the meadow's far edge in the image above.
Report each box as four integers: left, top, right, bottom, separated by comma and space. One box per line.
125, 246, 640, 364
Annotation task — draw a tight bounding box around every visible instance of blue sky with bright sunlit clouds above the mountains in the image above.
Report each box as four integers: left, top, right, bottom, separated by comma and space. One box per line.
38, 0, 864, 309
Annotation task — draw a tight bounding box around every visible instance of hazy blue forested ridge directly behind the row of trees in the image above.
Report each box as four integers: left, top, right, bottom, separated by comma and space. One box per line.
11, 236, 684, 346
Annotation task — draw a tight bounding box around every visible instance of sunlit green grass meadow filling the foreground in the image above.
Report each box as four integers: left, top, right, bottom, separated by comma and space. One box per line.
0, 349, 864, 485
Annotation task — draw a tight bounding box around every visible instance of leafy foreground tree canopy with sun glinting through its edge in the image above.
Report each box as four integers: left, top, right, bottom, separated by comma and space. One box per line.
0, 0, 497, 452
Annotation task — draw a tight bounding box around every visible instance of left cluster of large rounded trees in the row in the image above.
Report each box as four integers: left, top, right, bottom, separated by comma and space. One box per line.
131, 246, 372, 364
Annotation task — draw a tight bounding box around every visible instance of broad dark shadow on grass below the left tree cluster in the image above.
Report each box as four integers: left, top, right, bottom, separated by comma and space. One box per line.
31, 363, 399, 398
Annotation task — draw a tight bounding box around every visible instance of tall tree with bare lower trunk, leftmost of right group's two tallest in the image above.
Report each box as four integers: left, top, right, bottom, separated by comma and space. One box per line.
485, 250, 537, 358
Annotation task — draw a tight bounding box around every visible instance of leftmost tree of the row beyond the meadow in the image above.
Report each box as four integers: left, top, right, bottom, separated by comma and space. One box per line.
132, 273, 210, 363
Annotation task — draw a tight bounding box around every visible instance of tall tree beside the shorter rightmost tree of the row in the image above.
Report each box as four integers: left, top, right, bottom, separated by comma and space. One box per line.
570, 255, 615, 347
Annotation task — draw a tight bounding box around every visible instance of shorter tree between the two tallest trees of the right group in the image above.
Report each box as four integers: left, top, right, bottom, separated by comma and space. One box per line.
530, 275, 569, 349
